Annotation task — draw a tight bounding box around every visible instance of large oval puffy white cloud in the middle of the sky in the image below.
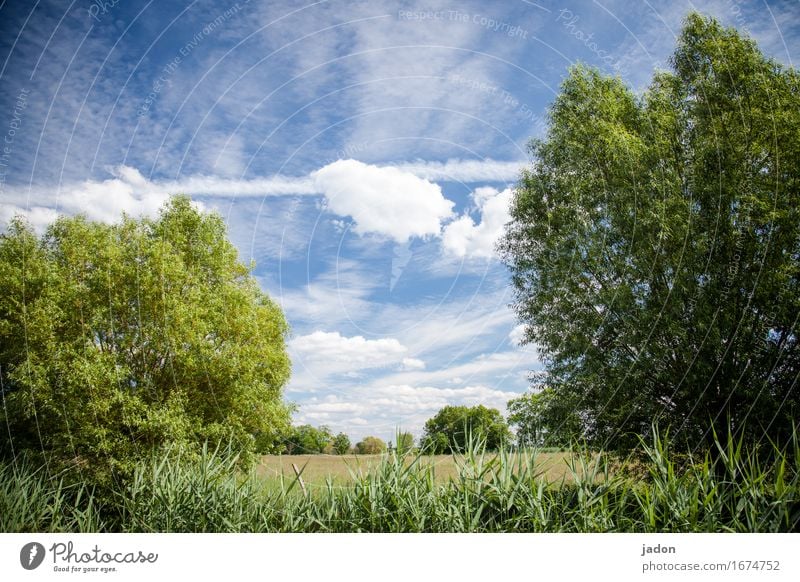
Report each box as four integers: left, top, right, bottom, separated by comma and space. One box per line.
312, 160, 453, 243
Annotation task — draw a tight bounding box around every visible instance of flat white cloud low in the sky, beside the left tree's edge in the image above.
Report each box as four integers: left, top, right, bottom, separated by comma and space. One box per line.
289, 331, 408, 369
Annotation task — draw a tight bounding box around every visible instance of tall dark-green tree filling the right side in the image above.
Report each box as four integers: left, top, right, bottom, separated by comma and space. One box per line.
500, 14, 800, 447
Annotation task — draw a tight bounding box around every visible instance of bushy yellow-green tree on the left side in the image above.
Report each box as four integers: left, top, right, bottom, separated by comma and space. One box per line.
0, 197, 290, 482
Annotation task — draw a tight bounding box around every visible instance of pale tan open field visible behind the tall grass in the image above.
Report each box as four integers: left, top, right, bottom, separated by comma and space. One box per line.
256, 453, 571, 487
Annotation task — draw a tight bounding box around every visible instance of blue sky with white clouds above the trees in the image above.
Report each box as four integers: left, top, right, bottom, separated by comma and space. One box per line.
0, 0, 800, 442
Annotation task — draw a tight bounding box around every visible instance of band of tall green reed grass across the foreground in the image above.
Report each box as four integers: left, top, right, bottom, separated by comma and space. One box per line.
0, 434, 800, 532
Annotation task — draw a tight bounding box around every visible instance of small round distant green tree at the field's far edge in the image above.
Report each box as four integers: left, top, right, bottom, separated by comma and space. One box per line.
420, 404, 510, 455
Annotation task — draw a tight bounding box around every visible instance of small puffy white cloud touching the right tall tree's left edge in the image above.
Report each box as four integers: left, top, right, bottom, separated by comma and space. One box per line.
442, 187, 513, 258
